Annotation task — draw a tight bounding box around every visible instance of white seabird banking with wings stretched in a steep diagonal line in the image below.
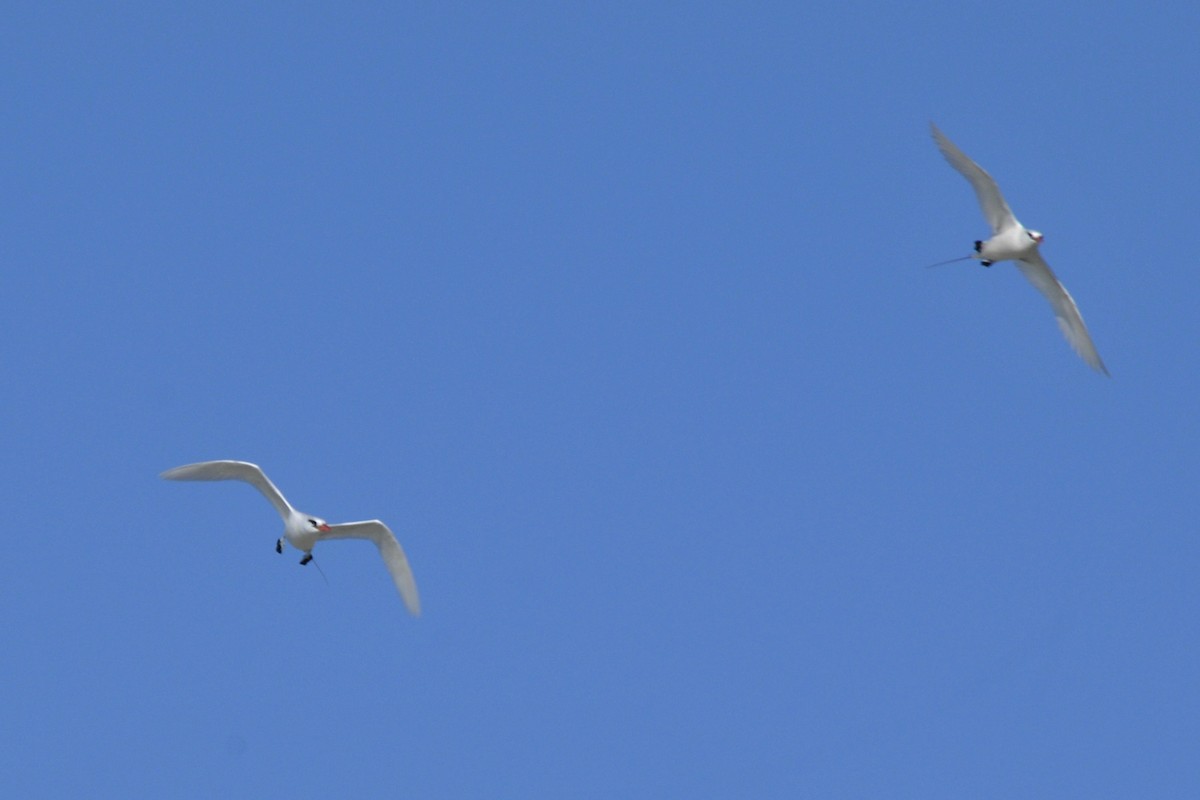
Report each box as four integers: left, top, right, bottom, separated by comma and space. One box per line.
930, 124, 1109, 375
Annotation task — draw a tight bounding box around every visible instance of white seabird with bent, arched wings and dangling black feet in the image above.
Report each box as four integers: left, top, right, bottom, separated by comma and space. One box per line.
161, 461, 421, 615
